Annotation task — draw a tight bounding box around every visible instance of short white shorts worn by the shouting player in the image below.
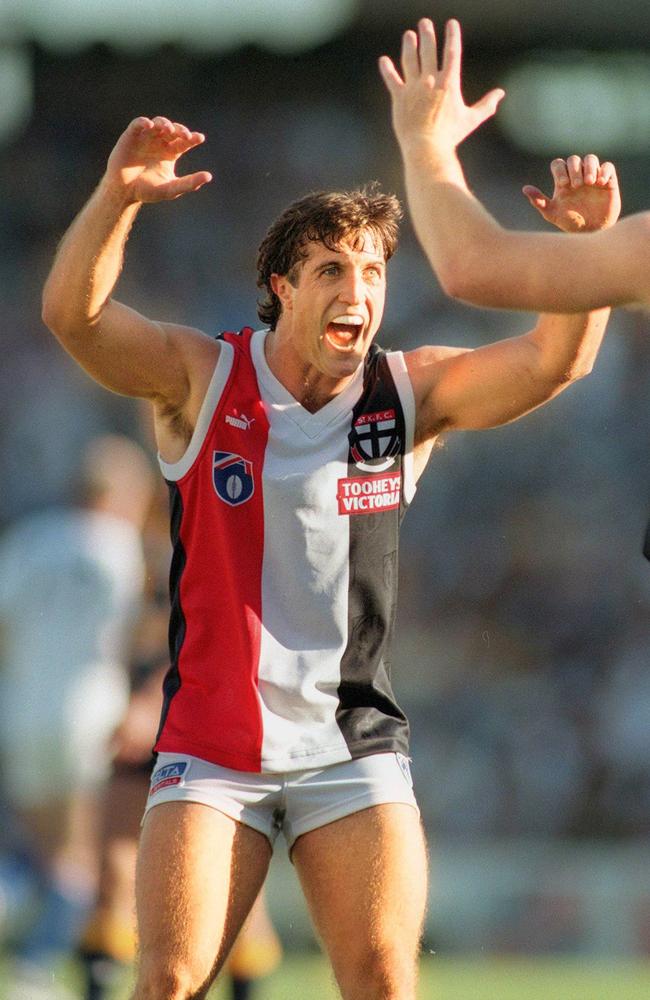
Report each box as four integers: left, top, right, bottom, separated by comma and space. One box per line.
145, 753, 419, 850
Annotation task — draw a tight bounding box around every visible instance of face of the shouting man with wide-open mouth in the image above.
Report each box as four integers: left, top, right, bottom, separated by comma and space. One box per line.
276, 231, 386, 379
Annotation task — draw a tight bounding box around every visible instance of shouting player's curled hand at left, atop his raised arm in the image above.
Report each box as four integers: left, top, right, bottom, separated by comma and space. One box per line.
105, 118, 212, 202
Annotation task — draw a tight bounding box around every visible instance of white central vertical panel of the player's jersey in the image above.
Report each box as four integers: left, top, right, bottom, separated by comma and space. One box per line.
251, 331, 363, 771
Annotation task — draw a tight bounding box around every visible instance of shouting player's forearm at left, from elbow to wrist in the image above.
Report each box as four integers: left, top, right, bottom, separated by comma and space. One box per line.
43, 180, 140, 340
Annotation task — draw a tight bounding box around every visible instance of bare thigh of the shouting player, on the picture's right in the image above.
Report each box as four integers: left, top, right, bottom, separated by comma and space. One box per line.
292, 803, 427, 1000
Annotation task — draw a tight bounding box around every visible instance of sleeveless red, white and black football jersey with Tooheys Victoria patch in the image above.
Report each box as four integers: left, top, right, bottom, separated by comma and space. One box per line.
156, 328, 415, 772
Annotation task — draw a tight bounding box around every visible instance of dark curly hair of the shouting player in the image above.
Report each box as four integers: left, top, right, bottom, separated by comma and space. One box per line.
257, 183, 402, 330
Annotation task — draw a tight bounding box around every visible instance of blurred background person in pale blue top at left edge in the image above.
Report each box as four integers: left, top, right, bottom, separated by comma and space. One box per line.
0, 435, 154, 1000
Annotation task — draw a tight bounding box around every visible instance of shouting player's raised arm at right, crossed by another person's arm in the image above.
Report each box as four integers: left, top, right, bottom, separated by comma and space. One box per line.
407, 156, 620, 443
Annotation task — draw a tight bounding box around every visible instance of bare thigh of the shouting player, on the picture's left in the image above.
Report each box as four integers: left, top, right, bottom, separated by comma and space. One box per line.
135, 802, 271, 1000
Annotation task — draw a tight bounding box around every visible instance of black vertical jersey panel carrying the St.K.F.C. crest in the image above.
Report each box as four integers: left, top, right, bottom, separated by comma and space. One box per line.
336, 344, 409, 757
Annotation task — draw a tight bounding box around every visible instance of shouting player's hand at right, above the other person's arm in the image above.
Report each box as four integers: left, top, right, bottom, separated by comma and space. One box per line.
523, 153, 621, 233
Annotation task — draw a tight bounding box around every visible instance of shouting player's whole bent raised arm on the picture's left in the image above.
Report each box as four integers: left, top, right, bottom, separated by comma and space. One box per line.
43, 118, 213, 411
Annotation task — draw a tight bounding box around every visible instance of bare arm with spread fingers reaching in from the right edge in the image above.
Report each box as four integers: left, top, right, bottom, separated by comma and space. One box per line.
380, 19, 650, 312
